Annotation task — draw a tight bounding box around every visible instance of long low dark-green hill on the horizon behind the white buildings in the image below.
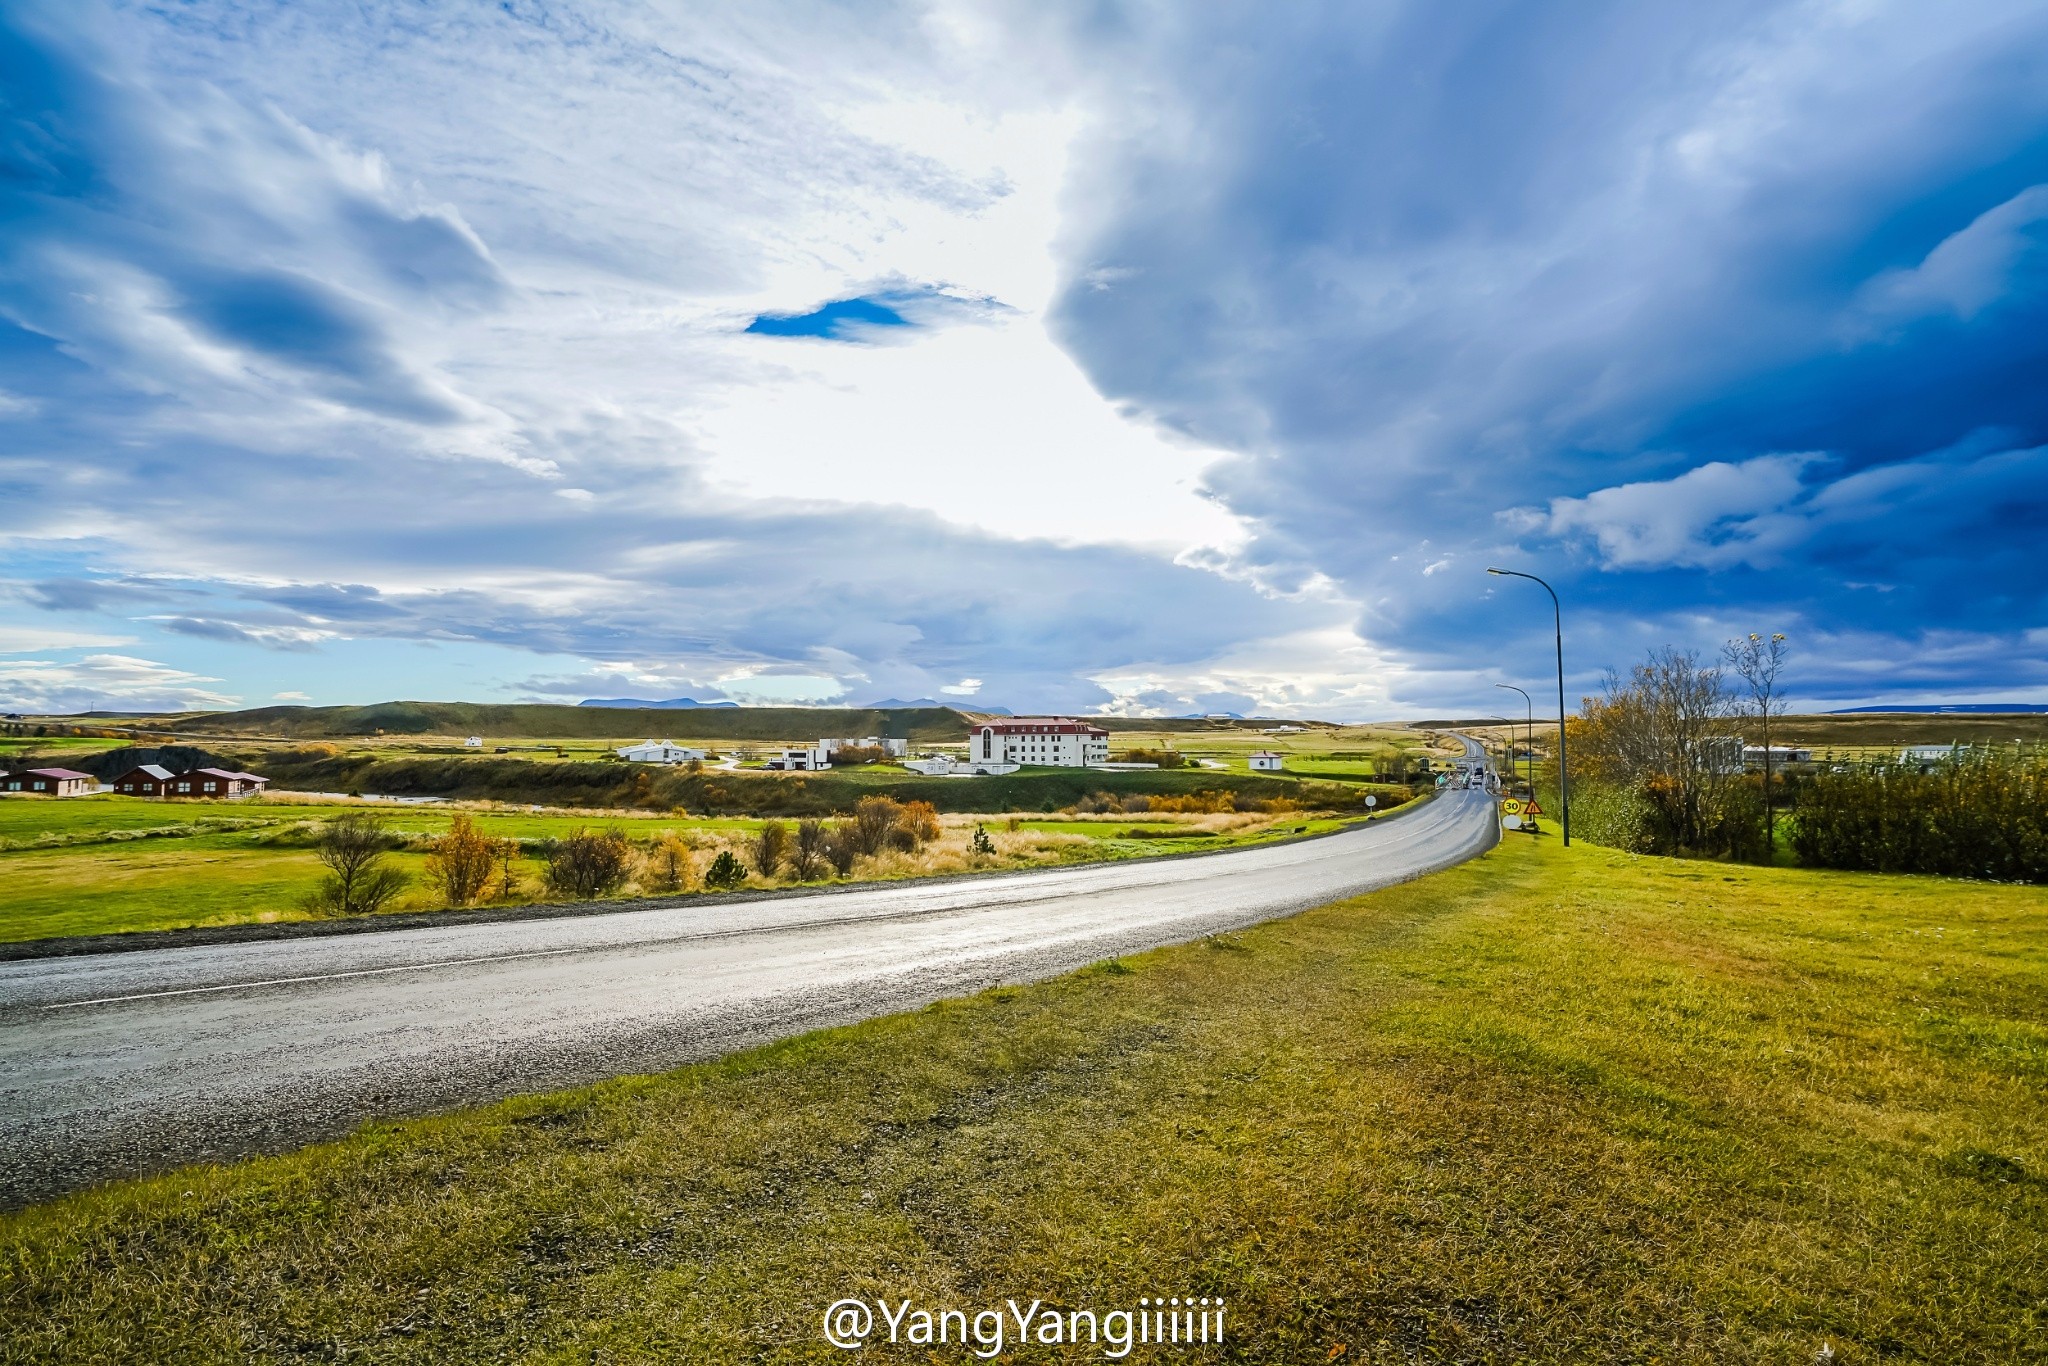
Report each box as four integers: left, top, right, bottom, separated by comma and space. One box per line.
138, 702, 967, 743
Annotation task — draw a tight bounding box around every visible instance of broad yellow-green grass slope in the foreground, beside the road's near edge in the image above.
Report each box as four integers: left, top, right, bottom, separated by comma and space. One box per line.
0, 842, 2048, 1364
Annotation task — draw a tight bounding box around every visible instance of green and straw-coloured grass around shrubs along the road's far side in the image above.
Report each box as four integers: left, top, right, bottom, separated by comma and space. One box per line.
0, 797, 1376, 942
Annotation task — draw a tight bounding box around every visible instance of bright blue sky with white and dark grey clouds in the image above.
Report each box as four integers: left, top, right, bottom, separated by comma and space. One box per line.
0, 0, 2048, 719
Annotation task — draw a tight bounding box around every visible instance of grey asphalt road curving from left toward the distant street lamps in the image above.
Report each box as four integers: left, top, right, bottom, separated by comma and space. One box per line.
0, 749, 1499, 1206
